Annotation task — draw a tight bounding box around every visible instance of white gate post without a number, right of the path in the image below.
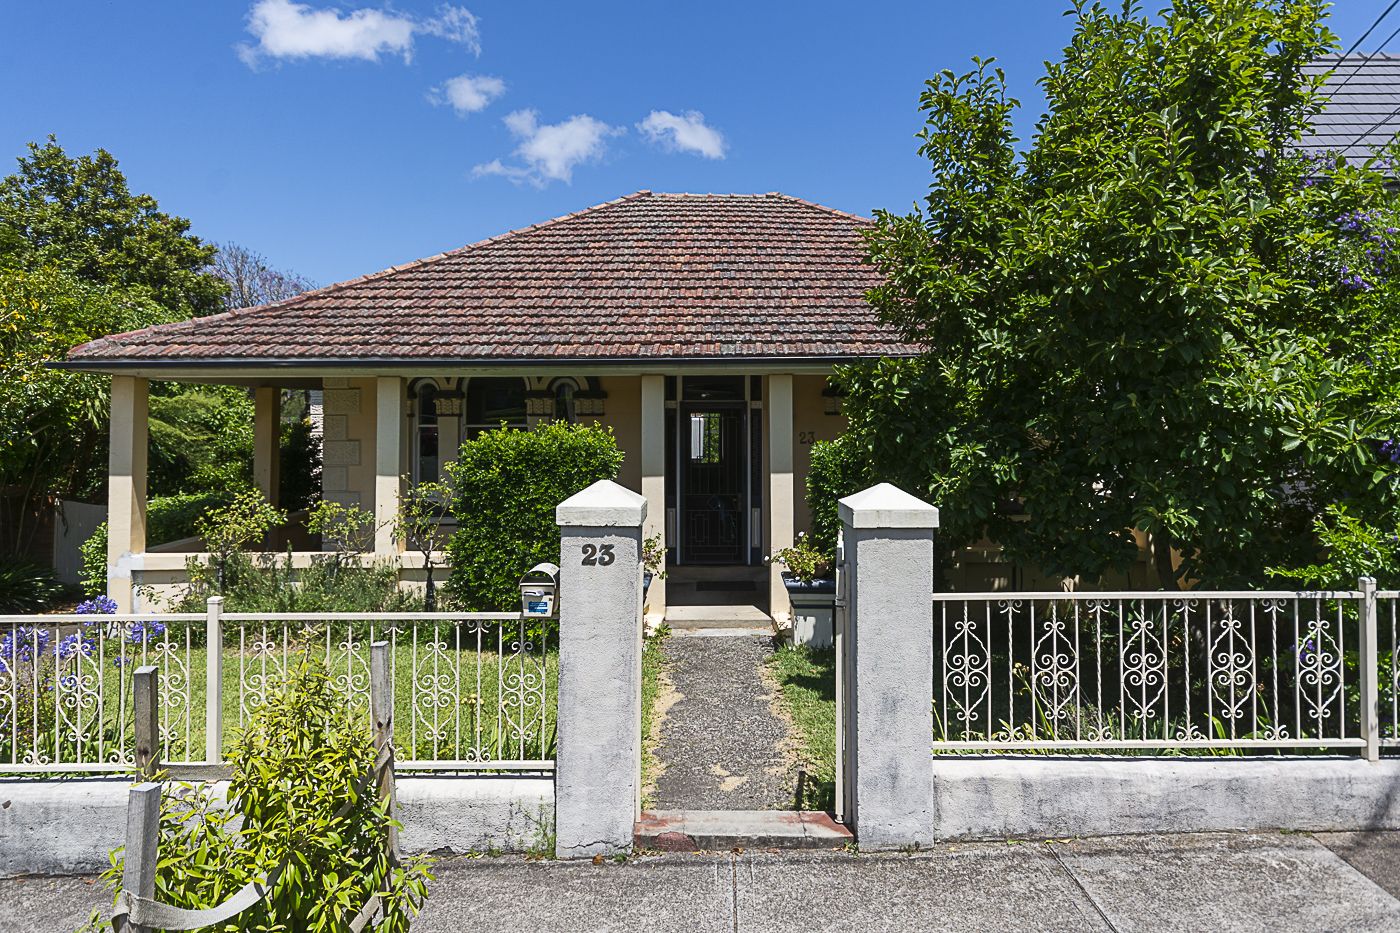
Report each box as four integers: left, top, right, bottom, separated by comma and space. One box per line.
837, 483, 938, 849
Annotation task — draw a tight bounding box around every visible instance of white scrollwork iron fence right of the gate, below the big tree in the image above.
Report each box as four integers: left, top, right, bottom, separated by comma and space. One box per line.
934, 580, 1400, 758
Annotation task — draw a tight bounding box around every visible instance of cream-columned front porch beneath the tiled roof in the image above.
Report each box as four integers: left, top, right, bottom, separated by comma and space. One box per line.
108, 367, 844, 625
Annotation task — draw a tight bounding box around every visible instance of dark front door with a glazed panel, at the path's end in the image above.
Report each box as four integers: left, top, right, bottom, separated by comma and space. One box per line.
678, 402, 749, 565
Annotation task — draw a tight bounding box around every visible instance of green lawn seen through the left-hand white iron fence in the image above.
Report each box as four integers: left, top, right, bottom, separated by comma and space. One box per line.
0, 625, 559, 763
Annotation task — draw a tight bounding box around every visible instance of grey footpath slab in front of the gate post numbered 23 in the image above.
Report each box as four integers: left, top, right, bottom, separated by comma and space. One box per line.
413, 856, 734, 933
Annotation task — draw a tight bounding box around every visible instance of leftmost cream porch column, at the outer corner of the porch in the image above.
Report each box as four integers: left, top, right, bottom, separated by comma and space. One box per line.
106, 375, 150, 612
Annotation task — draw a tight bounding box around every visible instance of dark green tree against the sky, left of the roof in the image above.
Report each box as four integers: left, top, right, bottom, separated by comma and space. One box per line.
0, 136, 228, 317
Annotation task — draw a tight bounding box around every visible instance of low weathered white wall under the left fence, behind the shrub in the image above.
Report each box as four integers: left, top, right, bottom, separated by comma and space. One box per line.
0, 776, 554, 877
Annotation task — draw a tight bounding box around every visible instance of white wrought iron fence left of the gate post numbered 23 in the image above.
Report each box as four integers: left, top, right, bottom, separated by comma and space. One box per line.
0, 600, 559, 773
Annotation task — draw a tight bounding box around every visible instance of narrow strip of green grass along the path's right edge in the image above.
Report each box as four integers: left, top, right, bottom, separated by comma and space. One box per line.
769, 646, 836, 810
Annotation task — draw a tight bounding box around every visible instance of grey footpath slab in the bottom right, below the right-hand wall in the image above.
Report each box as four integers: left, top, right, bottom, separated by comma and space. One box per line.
1046, 834, 1400, 933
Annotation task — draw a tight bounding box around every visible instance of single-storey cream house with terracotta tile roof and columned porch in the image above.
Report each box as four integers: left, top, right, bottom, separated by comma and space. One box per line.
60, 191, 913, 616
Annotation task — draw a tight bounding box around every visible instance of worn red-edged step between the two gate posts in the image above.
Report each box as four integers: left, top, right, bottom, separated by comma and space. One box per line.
633, 810, 854, 852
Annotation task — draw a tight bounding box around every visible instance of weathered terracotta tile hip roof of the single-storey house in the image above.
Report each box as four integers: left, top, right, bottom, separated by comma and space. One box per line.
69, 191, 910, 368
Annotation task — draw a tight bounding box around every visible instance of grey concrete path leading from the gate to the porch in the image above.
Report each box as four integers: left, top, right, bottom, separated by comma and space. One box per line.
651, 635, 794, 810
